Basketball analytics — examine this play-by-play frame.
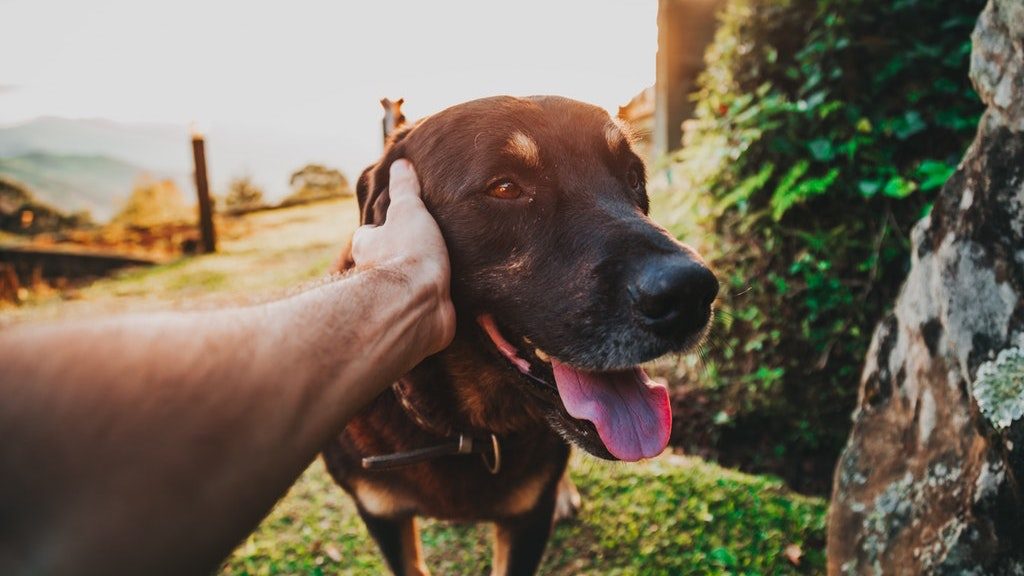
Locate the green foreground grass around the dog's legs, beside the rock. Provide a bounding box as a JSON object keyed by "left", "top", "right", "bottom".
{"left": 221, "top": 455, "right": 825, "bottom": 576}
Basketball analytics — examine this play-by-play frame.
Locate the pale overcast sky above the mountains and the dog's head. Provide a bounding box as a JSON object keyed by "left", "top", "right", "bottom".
{"left": 0, "top": 0, "right": 657, "bottom": 179}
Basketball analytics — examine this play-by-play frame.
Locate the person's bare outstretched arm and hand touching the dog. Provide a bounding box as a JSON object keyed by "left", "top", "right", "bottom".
{"left": 0, "top": 161, "right": 455, "bottom": 574}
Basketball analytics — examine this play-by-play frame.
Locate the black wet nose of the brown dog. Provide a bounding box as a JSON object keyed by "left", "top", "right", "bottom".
{"left": 629, "top": 256, "right": 718, "bottom": 336}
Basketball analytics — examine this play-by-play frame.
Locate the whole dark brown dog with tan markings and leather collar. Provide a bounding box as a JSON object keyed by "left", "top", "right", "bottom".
{"left": 324, "top": 96, "right": 718, "bottom": 574}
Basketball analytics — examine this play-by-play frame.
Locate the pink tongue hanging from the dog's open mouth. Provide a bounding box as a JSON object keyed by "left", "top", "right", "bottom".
{"left": 551, "top": 358, "right": 672, "bottom": 462}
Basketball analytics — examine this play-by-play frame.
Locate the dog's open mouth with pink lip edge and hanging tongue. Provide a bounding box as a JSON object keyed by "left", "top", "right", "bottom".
{"left": 477, "top": 315, "right": 672, "bottom": 461}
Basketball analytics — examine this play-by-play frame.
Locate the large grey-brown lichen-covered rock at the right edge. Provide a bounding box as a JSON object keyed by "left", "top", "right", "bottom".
{"left": 828, "top": 0, "right": 1024, "bottom": 575}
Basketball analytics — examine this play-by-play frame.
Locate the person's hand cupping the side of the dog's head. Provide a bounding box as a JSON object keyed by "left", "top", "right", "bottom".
{"left": 351, "top": 160, "right": 455, "bottom": 356}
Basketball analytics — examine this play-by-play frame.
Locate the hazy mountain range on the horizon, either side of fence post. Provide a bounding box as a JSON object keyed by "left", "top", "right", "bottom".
{"left": 0, "top": 117, "right": 364, "bottom": 219}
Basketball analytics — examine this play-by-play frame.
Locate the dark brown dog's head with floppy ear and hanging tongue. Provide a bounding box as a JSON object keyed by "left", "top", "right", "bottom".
{"left": 357, "top": 96, "right": 718, "bottom": 460}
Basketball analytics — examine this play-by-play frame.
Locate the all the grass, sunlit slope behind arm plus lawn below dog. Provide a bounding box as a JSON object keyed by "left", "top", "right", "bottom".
{"left": 0, "top": 200, "right": 825, "bottom": 575}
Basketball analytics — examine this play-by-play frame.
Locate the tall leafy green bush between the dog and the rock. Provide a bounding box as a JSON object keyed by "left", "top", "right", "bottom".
{"left": 655, "top": 0, "right": 983, "bottom": 490}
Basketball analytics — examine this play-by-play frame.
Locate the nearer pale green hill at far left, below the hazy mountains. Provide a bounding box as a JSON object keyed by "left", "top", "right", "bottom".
{"left": 0, "top": 152, "right": 184, "bottom": 221}
